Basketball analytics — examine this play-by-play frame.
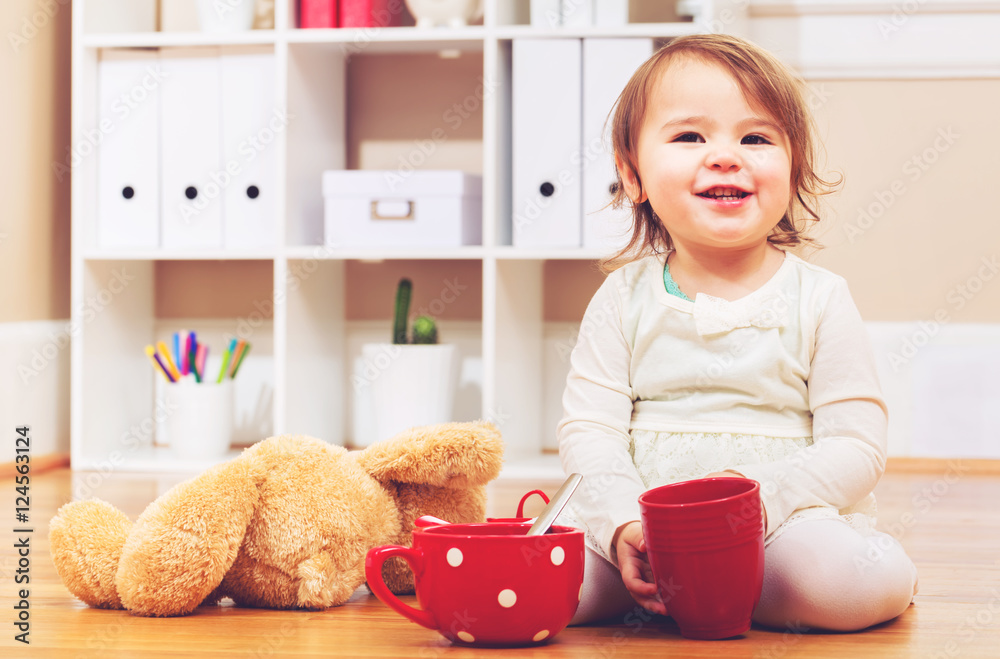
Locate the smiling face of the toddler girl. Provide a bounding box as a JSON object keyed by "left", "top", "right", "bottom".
{"left": 620, "top": 57, "right": 791, "bottom": 250}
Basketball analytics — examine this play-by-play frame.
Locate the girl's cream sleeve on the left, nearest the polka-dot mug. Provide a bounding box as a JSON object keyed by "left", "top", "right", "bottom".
{"left": 558, "top": 275, "right": 646, "bottom": 557}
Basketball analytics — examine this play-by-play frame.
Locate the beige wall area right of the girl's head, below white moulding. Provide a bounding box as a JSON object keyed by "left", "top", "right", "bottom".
{"left": 814, "top": 80, "right": 1000, "bottom": 323}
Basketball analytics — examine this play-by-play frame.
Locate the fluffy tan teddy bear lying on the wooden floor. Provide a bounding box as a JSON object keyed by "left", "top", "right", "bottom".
{"left": 49, "top": 422, "right": 503, "bottom": 616}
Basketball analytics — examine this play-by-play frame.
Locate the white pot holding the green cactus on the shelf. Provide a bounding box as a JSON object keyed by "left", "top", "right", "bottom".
{"left": 354, "top": 343, "right": 459, "bottom": 446}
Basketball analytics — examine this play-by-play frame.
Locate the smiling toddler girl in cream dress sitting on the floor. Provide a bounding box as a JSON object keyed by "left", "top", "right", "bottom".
{"left": 559, "top": 35, "right": 916, "bottom": 630}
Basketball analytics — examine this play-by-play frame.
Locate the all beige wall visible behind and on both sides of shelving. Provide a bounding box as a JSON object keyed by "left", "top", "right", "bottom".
{"left": 0, "top": 10, "right": 1000, "bottom": 322}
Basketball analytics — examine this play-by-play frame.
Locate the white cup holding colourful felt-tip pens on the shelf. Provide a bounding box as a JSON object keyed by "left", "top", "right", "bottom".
{"left": 164, "top": 378, "right": 233, "bottom": 459}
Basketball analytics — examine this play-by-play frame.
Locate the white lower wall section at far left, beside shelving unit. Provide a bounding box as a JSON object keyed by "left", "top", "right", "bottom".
{"left": 0, "top": 320, "right": 70, "bottom": 462}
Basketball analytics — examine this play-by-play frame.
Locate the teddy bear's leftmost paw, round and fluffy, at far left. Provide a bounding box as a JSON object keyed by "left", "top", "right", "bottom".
{"left": 49, "top": 499, "right": 132, "bottom": 609}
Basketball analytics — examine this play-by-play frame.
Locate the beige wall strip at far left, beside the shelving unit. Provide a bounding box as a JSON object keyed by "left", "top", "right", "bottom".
{"left": 0, "top": 0, "right": 70, "bottom": 322}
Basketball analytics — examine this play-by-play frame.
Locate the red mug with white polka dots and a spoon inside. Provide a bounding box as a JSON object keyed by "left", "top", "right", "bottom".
{"left": 365, "top": 522, "right": 584, "bottom": 646}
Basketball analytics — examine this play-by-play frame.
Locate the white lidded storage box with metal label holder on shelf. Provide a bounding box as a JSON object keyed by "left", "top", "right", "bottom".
{"left": 323, "top": 170, "right": 483, "bottom": 247}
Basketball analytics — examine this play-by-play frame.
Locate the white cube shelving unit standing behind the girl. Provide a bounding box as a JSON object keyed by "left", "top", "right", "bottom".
{"left": 71, "top": 0, "right": 746, "bottom": 477}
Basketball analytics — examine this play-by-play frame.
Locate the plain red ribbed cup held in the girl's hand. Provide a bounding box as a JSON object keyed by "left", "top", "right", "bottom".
{"left": 639, "top": 478, "right": 764, "bottom": 639}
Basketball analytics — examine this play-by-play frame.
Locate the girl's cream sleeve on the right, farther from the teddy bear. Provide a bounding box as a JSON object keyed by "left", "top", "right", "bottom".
{"left": 727, "top": 280, "right": 888, "bottom": 535}
